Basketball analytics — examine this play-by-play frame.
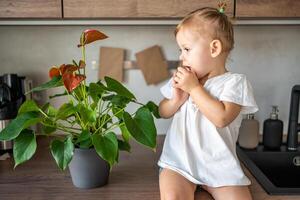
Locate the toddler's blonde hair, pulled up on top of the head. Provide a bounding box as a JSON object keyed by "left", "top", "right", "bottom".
{"left": 175, "top": 7, "right": 234, "bottom": 52}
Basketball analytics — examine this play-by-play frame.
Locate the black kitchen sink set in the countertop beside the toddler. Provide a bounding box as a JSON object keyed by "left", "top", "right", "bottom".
{"left": 236, "top": 144, "right": 300, "bottom": 195}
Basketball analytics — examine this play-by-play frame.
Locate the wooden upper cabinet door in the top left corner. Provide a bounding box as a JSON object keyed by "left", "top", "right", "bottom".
{"left": 0, "top": 0, "right": 62, "bottom": 18}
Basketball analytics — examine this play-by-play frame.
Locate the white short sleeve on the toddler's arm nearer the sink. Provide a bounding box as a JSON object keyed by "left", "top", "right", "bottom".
{"left": 219, "top": 74, "right": 258, "bottom": 114}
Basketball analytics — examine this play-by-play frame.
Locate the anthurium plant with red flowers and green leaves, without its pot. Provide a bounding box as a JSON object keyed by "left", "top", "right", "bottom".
{"left": 0, "top": 29, "right": 159, "bottom": 170}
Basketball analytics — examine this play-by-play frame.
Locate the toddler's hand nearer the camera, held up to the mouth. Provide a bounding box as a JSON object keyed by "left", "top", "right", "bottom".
{"left": 173, "top": 67, "right": 200, "bottom": 94}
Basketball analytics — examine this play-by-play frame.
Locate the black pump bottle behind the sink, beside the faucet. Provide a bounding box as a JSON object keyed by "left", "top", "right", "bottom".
{"left": 263, "top": 106, "right": 283, "bottom": 149}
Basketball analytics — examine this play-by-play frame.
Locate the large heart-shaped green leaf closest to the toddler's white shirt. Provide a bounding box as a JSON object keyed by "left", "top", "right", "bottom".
{"left": 123, "top": 107, "right": 157, "bottom": 148}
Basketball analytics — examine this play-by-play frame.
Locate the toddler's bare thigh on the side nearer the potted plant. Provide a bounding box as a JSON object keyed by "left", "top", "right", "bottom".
{"left": 159, "top": 169, "right": 196, "bottom": 200}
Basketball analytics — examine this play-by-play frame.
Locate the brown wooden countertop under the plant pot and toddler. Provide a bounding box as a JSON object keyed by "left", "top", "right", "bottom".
{"left": 0, "top": 136, "right": 300, "bottom": 200}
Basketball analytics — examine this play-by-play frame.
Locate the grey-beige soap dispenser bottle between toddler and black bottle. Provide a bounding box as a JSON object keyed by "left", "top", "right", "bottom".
{"left": 238, "top": 114, "right": 259, "bottom": 149}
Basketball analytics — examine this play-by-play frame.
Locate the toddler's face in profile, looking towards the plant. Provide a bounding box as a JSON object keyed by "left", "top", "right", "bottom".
{"left": 176, "top": 28, "right": 211, "bottom": 79}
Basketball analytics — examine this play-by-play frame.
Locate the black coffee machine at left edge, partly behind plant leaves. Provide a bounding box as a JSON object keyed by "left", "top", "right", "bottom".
{"left": 0, "top": 74, "right": 26, "bottom": 153}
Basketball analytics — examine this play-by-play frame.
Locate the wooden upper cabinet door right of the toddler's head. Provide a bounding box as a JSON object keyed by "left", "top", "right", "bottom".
{"left": 236, "top": 0, "right": 300, "bottom": 18}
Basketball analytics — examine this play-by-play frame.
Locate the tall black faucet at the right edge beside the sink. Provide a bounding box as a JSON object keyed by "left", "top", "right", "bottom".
{"left": 287, "top": 85, "right": 300, "bottom": 151}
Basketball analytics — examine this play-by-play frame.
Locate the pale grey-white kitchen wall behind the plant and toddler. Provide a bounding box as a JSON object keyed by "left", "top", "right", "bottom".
{"left": 0, "top": 25, "right": 300, "bottom": 133}
